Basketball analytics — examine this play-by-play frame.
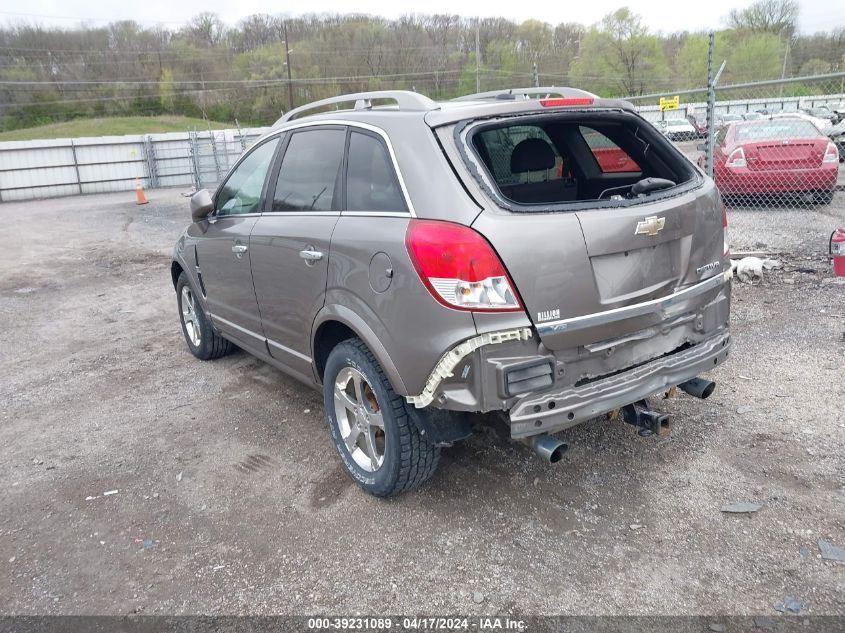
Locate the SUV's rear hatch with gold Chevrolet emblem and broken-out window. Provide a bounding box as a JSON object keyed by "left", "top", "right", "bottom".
{"left": 428, "top": 103, "right": 724, "bottom": 350}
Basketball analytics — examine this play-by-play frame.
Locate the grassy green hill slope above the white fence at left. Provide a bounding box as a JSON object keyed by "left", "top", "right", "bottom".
{"left": 0, "top": 115, "right": 235, "bottom": 141}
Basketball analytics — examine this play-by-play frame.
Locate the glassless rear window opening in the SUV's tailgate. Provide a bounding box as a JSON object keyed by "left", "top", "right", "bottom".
{"left": 467, "top": 113, "right": 695, "bottom": 206}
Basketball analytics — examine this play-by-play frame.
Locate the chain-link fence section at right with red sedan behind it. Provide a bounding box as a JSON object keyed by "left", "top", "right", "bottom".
{"left": 630, "top": 73, "right": 845, "bottom": 208}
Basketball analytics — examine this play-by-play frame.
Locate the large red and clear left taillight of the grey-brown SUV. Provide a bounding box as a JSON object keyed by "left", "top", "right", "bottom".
{"left": 405, "top": 220, "right": 522, "bottom": 312}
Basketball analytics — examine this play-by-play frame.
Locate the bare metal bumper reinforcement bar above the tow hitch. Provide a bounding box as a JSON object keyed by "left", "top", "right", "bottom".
{"left": 510, "top": 330, "right": 731, "bottom": 438}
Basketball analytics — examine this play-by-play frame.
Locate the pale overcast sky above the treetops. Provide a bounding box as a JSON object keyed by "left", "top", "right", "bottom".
{"left": 0, "top": 0, "right": 845, "bottom": 33}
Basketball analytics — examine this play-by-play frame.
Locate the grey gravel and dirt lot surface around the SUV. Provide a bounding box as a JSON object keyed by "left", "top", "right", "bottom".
{"left": 0, "top": 190, "right": 845, "bottom": 617}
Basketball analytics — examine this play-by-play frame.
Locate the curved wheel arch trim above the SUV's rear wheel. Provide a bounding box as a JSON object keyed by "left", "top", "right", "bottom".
{"left": 311, "top": 305, "right": 408, "bottom": 396}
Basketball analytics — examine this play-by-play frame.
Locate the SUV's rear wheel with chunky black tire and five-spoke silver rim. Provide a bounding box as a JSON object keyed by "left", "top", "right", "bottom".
{"left": 323, "top": 338, "right": 440, "bottom": 497}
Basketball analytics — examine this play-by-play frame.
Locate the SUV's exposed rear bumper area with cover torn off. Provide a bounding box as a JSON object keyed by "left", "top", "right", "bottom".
{"left": 407, "top": 271, "right": 730, "bottom": 438}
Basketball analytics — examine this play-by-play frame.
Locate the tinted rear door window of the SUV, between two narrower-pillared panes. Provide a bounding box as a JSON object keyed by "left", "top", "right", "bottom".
{"left": 272, "top": 128, "right": 346, "bottom": 211}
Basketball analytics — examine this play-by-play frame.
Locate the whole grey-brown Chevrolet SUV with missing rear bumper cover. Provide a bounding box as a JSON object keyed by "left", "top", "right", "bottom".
{"left": 171, "top": 88, "right": 730, "bottom": 496}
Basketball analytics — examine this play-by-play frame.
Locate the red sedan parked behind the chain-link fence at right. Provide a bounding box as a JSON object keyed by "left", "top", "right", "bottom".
{"left": 699, "top": 118, "right": 839, "bottom": 204}
